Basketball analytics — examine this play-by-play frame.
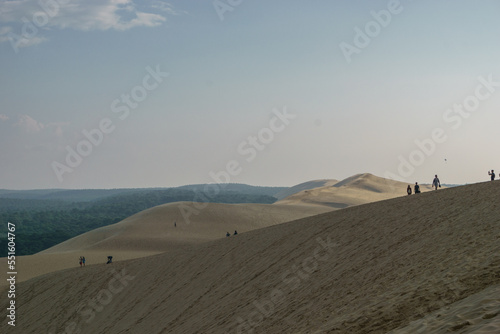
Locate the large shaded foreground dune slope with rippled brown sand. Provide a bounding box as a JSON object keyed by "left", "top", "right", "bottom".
{"left": 4, "top": 182, "right": 500, "bottom": 334}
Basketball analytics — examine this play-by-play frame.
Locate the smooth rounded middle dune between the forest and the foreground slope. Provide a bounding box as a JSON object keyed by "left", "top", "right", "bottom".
{"left": 0, "top": 202, "right": 328, "bottom": 285}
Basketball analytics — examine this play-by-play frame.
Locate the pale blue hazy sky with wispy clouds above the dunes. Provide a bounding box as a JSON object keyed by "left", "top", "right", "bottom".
{"left": 0, "top": 0, "right": 500, "bottom": 189}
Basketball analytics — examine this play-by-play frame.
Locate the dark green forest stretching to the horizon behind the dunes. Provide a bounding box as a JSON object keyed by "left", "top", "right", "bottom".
{"left": 0, "top": 186, "right": 283, "bottom": 257}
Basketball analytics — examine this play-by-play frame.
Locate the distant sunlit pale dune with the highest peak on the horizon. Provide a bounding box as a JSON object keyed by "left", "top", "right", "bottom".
{"left": 277, "top": 173, "right": 432, "bottom": 209}
